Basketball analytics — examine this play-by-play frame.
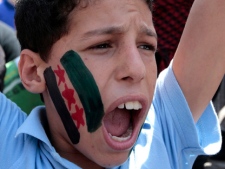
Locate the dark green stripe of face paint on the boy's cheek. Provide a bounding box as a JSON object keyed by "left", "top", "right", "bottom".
{"left": 60, "top": 50, "right": 104, "bottom": 132}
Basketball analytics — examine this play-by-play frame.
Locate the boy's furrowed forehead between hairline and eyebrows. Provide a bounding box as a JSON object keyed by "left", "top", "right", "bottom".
{"left": 70, "top": 0, "right": 154, "bottom": 34}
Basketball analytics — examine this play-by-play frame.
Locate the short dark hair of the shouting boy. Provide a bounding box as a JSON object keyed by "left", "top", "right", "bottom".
{"left": 15, "top": 0, "right": 152, "bottom": 61}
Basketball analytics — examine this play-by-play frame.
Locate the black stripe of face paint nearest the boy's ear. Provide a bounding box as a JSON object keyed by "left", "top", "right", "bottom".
{"left": 44, "top": 67, "right": 80, "bottom": 144}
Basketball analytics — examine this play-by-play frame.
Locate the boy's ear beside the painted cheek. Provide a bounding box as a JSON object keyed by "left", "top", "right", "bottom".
{"left": 18, "top": 49, "right": 47, "bottom": 93}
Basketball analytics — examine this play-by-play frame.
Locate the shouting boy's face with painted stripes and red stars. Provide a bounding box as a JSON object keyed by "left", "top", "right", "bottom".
{"left": 44, "top": 0, "right": 157, "bottom": 167}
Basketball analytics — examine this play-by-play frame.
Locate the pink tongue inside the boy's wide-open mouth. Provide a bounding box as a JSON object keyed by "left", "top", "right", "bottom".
{"left": 104, "top": 109, "right": 131, "bottom": 137}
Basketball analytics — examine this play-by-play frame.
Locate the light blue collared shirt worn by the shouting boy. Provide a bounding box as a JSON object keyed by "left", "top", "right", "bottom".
{"left": 0, "top": 65, "right": 221, "bottom": 169}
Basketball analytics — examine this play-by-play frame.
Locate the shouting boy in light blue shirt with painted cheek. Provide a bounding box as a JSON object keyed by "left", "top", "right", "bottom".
{"left": 0, "top": 0, "right": 225, "bottom": 169}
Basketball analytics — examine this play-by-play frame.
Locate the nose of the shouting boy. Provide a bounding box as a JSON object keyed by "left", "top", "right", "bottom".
{"left": 116, "top": 45, "right": 146, "bottom": 83}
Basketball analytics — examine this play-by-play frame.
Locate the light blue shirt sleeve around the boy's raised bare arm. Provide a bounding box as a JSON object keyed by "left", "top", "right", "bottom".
{"left": 153, "top": 62, "right": 221, "bottom": 168}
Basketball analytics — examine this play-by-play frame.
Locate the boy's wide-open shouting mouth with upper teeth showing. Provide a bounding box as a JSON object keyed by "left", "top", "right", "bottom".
{"left": 103, "top": 101, "right": 143, "bottom": 150}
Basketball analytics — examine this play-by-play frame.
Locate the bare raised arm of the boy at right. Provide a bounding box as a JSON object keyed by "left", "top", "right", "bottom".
{"left": 173, "top": 0, "right": 225, "bottom": 121}
